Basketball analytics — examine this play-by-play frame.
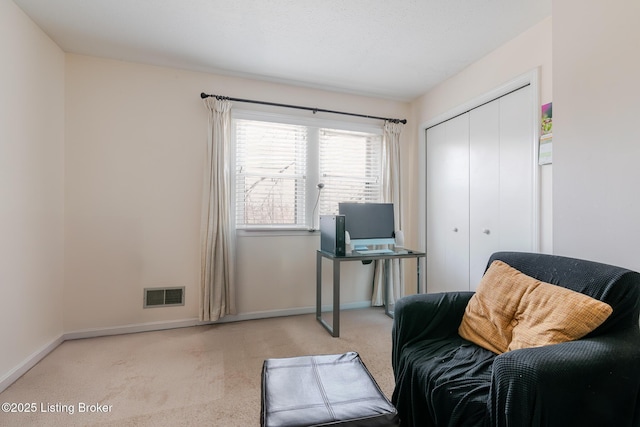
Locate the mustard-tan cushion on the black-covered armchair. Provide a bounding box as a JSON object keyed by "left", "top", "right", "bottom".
{"left": 458, "top": 261, "right": 613, "bottom": 354}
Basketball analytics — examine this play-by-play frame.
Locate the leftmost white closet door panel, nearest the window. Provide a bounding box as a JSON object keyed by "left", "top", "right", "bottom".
{"left": 426, "top": 114, "right": 469, "bottom": 292}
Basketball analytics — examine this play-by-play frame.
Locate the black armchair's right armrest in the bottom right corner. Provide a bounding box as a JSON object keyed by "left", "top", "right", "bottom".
{"left": 488, "top": 328, "right": 640, "bottom": 427}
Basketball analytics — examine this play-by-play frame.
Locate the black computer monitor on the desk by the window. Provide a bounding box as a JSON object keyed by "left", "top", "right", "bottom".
{"left": 338, "top": 202, "right": 395, "bottom": 250}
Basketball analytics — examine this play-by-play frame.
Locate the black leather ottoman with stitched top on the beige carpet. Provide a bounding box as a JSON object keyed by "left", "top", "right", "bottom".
{"left": 260, "top": 352, "right": 400, "bottom": 427}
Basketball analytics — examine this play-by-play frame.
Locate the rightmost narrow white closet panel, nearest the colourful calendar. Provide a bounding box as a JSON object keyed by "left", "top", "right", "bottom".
{"left": 499, "top": 86, "right": 534, "bottom": 251}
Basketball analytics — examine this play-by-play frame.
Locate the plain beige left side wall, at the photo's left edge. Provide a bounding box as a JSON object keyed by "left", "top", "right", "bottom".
{"left": 0, "top": 0, "right": 64, "bottom": 390}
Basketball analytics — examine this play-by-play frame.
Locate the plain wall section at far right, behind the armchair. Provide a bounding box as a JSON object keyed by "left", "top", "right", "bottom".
{"left": 553, "top": 0, "right": 640, "bottom": 270}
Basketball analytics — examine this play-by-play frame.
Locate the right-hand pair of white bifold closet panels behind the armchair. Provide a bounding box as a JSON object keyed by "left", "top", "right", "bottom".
{"left": 469, "top": 86, "right": 534, "bottom": 290}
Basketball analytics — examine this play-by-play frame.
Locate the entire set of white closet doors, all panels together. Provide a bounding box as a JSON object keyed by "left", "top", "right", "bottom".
{"left": 426, "top": 86, "right": 536, "bottom": 292}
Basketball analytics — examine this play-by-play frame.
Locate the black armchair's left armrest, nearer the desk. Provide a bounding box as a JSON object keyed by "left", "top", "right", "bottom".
{"left": 391, "top": 292, "right": 473, "bottom": 372}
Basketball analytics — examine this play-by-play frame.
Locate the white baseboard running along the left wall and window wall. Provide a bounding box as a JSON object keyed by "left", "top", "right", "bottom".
{"left": 0, "top": 301, "right": 371, "bottom": 392}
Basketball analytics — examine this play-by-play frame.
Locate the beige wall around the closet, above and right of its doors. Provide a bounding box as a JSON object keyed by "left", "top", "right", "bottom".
{"left": 411, "top": 17, "right": 553, "bottom": 260}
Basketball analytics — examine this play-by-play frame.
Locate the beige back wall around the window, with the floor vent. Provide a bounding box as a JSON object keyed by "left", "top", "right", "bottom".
{"left": 65, "top": 55, "right": 409, "bottom": 332}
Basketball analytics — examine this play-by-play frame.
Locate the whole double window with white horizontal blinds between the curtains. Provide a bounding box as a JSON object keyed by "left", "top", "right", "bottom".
{"left": 238, "top": 113, "right": 382, "bottom": 229}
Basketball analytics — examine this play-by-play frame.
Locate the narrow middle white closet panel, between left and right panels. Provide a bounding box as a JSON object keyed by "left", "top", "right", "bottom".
{"left": 469, "top": 100, "right": 501, "bottom": 290}
